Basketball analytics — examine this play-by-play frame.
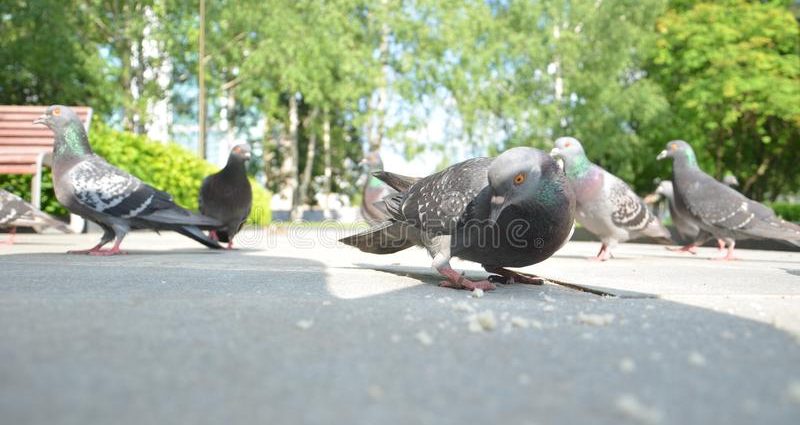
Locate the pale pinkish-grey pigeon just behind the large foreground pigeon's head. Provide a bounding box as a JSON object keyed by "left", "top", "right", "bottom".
{"left": 550, "top": 137, "right": 670, "bottom": 261}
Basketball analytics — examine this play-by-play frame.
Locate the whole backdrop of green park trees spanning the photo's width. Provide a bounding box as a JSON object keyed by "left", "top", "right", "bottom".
{"left": 0, "top": 0, "right": 800, "bottom": 205}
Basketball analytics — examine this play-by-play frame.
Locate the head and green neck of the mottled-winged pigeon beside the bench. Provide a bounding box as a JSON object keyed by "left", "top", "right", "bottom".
{"left": 33, "top": 105, "right": 92, "bottom": 157}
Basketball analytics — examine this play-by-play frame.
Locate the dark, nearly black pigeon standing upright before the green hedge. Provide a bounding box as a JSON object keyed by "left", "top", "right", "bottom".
{"left": 198, "top": 144, "right": 253, "bottom": 249}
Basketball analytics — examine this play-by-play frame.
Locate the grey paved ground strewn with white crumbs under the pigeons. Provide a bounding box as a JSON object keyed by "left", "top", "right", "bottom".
{"left": 0, "top": 226, "right": 800, "bottom": 425}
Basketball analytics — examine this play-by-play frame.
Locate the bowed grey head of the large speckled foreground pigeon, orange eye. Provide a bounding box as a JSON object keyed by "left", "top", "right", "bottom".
{"left": 488, "top": 147, "right": 563, "bottom": 222}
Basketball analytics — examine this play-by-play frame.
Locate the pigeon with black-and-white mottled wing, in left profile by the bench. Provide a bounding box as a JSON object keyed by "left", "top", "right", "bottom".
{"left": 34, "top": 105, "right": 222, "bottom": 255}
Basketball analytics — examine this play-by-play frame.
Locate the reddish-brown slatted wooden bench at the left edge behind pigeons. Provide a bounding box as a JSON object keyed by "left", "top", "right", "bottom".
{"left": 0, "top": 105, "right": 92, "bottom": 232}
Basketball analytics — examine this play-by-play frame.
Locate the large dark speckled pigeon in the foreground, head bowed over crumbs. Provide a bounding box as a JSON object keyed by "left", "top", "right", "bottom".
{"left": 341, "top": 147, "right": 575, "bottom": 290}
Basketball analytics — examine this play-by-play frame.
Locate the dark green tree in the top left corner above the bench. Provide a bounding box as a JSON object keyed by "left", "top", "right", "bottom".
{"left": 0, "top": 0, "right": 119, "bottom": 113}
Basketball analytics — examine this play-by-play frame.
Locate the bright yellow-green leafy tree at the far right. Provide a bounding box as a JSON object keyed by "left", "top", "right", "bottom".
{"left": 648, "top": 0, "right": 800, "bottom": 200}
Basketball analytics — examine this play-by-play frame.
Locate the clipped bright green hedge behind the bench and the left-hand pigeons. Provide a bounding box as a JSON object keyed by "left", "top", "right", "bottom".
{"left": 0, "top": 121, "right": 272, "bottom": 226}
